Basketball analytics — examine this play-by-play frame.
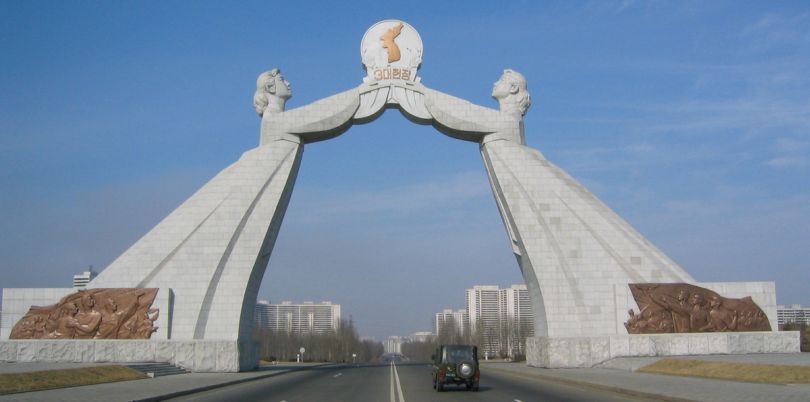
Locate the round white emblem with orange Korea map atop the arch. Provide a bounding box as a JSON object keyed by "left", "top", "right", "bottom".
{"left": 360, "top": 20, "right": 422, "bottom": 82}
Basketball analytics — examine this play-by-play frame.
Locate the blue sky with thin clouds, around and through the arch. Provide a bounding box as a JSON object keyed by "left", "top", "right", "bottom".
{"left": 0, "top": 1, "right": 810, "bottom": 338}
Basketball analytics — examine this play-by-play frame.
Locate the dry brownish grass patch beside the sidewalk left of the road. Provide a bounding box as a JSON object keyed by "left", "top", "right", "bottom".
{"left": 0, "top": 366, "right": 146, "bottom": 395}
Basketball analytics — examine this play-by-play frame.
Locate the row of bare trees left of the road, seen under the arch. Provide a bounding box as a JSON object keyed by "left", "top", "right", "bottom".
{"left": 254, "top": 320, "right": 384, "bottom": 363}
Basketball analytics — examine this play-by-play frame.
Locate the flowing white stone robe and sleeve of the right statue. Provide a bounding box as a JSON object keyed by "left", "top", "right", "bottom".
{"left": 420, "top": 88, "right": 694, "bottom": 337}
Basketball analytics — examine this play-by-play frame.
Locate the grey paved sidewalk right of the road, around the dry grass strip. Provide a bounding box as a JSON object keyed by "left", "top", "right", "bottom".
{"left": 482, "top": 353, "right": 810, "bottom": 402}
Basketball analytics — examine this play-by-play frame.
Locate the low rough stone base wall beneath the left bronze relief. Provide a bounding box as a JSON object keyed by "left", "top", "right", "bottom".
{"left": 0, "top": 340, "right": 259, "bottom": 373}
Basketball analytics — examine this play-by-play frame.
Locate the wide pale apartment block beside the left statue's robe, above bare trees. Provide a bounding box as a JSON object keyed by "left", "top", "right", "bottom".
{"left": 255, "top": 300, "right": 340, "bottom": 334}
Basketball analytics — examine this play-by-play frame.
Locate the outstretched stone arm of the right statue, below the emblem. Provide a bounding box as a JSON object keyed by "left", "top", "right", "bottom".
{"left": 419, "top": 86, "right": 500, "bottom": 142}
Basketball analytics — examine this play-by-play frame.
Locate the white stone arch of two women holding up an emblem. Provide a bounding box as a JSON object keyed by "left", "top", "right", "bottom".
{"left": 89, "top": 20, "right": 784, "bottom": 371}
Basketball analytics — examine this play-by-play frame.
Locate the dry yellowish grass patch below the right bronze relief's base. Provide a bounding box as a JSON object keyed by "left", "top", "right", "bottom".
{"left": 638, "top": 359, "right": 810, "bottom": 384}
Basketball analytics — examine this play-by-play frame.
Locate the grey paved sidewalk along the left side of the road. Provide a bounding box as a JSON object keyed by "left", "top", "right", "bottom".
{"left": 0, "top": 363, "right": 323, "bottom": 402}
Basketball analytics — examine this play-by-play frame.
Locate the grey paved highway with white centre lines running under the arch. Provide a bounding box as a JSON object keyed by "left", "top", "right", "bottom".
{"left": 167, "top": 364, "right": 652, "bottom": 402}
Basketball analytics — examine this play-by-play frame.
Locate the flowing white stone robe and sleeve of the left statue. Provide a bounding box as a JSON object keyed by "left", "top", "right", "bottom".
{"left": 88, "top": 88, "right": 360, "bottom": 341}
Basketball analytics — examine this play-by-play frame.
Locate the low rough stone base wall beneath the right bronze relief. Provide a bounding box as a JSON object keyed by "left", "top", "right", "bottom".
{"left": 526, "top": 331, "right": 800, "bottom": 368}
